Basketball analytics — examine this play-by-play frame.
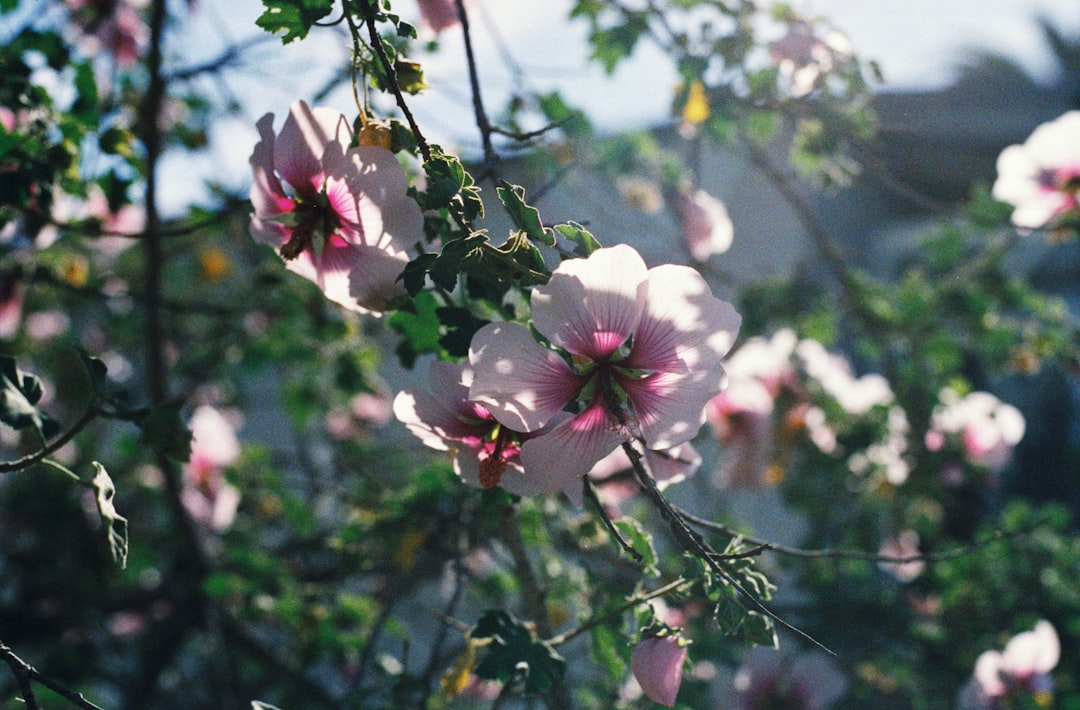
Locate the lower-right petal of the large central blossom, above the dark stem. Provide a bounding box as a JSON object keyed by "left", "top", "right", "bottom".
{"left": 619, "top": 365, "right": 726, "bottom": 448}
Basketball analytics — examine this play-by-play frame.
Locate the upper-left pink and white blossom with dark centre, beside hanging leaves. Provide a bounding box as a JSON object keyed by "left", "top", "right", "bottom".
{"left": 251, "top": 102, "right": 423, "bottom": 312}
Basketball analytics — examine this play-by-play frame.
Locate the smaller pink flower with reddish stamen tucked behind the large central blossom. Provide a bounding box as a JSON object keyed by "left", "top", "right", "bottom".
{"left": 393, "top": 360, "right": 561, "bottom": 496}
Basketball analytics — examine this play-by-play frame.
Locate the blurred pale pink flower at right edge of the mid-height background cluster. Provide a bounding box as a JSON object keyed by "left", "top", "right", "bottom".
{"left": 926, "top": 388, "right": 1025, "bottom": 470}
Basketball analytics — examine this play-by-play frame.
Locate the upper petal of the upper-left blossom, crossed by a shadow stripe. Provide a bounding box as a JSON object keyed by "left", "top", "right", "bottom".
{"left": 274, "top": 102, "right": 352, "bottom": 192}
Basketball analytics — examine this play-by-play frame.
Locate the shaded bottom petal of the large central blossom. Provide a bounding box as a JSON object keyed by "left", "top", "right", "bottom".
{"left": 521, "top": 401, "right": 627, "bottom": 493}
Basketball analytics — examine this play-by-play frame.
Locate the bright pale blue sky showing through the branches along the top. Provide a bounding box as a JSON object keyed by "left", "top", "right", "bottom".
{"left": 157, "top": 0, "right": 1080, "bottom": 213}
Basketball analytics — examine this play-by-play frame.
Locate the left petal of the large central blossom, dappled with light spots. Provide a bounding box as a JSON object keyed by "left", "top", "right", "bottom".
{"left": 469, "top": 323, "right": 586, "bottom": 431}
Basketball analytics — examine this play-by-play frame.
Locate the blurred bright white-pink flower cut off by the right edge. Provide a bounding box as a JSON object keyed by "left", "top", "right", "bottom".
{"left": 993, "top": 111, "right": 1080, "bottom": 229}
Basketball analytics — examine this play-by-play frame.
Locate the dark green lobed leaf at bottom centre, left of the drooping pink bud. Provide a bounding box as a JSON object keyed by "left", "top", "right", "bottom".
{"left": 470, "top": 609, "right": 566, "bottom": 694}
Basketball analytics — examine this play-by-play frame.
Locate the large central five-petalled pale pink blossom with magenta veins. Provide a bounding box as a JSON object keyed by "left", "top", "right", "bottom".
{"left": 469, "top": 245, "right": 741, "bottom": 492}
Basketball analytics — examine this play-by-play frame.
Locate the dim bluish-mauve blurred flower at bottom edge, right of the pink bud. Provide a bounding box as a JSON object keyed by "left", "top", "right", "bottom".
{"left": 734, "top": 646, "right": 848, "bottom": 710}
